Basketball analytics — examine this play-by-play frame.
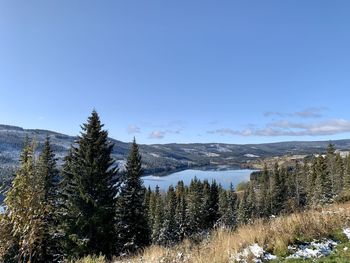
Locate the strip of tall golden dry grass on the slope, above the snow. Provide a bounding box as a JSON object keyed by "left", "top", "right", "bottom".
{"left": 120, "top": 203, "right": 350, "bottom": 263}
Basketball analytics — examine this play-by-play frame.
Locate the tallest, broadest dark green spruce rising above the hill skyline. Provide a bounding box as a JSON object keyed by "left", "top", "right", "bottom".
{"left": 61, "top": 111, "right": 117, "bottom": 257}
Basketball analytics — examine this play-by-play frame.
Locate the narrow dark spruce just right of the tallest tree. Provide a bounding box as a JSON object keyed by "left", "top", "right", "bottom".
{"left": 116, "top": 139, "right": 150, "bottom": 253}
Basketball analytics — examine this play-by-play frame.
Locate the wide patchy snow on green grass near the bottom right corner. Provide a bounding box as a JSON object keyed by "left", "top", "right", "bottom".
{"left": 287, "top": 239, "right": 338, "bottom": 259}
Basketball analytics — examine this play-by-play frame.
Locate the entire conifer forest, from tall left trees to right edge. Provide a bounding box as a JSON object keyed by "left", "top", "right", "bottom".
{"left": 0, "top": 111, "right": 350, "bottom": 263}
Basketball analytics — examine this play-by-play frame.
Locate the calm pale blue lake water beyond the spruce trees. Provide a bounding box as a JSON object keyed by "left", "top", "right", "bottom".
{"left": 142, "top": 169, "right": 255, "bottom": 190}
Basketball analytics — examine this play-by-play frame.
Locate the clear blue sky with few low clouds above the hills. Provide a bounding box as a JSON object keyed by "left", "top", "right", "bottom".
{"left": 0, "top": 0, "right": 350, "bottom": 143}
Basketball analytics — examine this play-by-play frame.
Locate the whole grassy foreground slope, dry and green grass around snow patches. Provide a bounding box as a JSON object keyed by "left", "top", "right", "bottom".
{"left": 116, "top": 203, "right": 350, "bottom": 263}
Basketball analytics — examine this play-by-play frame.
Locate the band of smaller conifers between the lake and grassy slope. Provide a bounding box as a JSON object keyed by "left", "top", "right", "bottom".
{"left": 145, "top": 144, "right": 350, "bottom": 245}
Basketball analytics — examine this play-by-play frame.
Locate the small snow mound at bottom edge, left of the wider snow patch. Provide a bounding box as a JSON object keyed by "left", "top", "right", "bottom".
{"left": 232, "top": 244, "right": 277, "bottom": 263}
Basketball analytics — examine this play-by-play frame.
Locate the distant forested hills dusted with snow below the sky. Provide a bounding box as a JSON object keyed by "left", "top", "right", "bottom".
{"left": 0, "top": 125, "right": 350, "bottom": 175}
